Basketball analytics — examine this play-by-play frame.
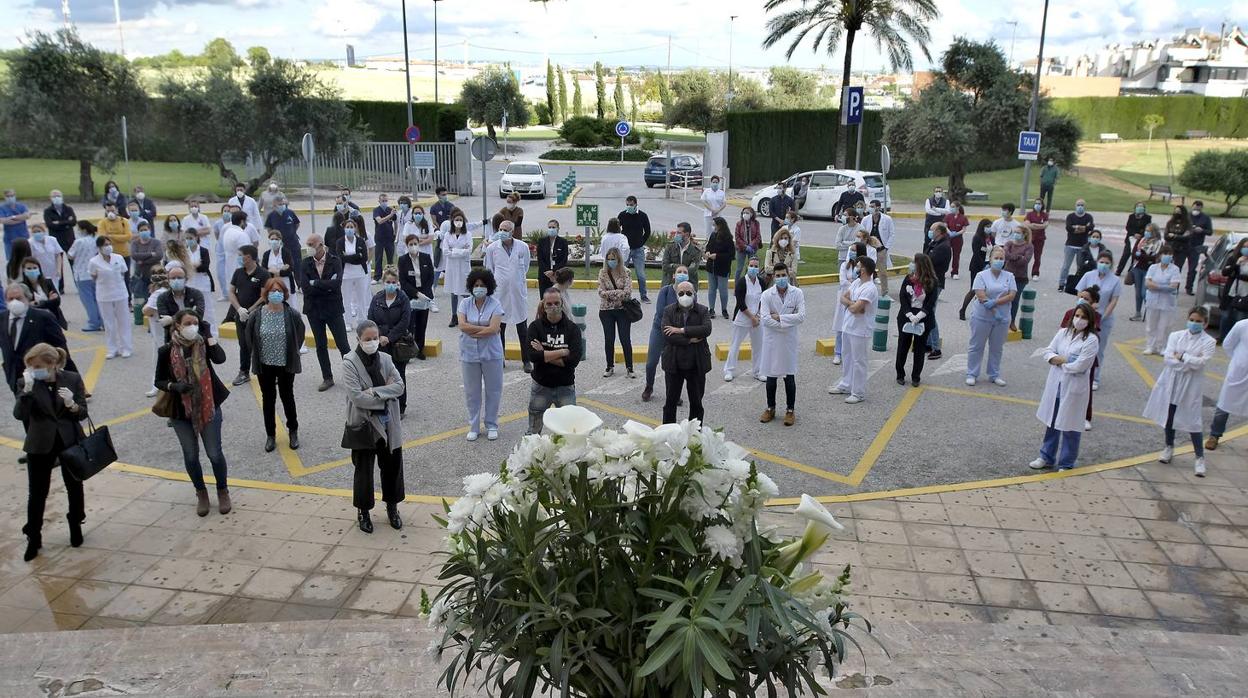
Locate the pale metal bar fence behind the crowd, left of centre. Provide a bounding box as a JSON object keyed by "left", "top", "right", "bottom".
{"left": 273, "top": 142, "right": 458, "bottom": 194}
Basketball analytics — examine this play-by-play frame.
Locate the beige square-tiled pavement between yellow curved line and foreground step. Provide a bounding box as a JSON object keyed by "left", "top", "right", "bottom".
{"left": 0, "top": 434, "right": 1248, "bottom": 633}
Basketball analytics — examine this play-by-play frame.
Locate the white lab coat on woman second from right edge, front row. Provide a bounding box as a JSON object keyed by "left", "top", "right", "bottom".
{"left": 1144, "top": 328, "right": 1218, "bottom": 433}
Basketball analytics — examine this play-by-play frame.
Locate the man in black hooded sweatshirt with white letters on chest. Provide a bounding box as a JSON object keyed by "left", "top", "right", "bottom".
{"left": 527, "top": 286, "right": 584, "bottom": 433}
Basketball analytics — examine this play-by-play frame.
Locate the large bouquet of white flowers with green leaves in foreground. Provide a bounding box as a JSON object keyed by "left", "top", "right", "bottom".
{"left": 429, "top": 406, "right": 870, "bottom": 698}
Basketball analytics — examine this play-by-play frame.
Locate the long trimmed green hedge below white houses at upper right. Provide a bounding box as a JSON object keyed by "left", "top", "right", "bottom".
{"left": 1051, "top": 95, "right": 1248, "bottom": 139}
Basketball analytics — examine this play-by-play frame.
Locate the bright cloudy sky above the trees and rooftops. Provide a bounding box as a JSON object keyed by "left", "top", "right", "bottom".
{"left": 0, "top": 0, "right": 1248, "bottom": 69}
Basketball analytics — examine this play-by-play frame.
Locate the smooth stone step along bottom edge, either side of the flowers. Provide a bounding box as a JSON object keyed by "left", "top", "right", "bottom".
{"left": 0, "top": 618, "right": 1248, "bottom": 697}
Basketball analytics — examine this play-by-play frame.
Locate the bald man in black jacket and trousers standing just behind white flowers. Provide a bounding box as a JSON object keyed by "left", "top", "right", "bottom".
{"left": 663, "top": 281, "right": 710, "bottom": 423}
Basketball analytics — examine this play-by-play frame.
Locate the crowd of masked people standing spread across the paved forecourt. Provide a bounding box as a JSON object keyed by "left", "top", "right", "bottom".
{"left": 0, "top": 177, "right": 1248, "bottom": 559}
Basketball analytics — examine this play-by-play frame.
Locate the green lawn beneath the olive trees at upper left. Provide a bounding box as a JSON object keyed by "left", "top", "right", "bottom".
{"left": 0, "top": 159, "right": 230, "bottom": 202}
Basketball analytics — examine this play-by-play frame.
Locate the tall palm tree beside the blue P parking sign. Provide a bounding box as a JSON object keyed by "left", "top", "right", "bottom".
{"left": 763, "top": 0, "right": 940, "bottom": 165}
